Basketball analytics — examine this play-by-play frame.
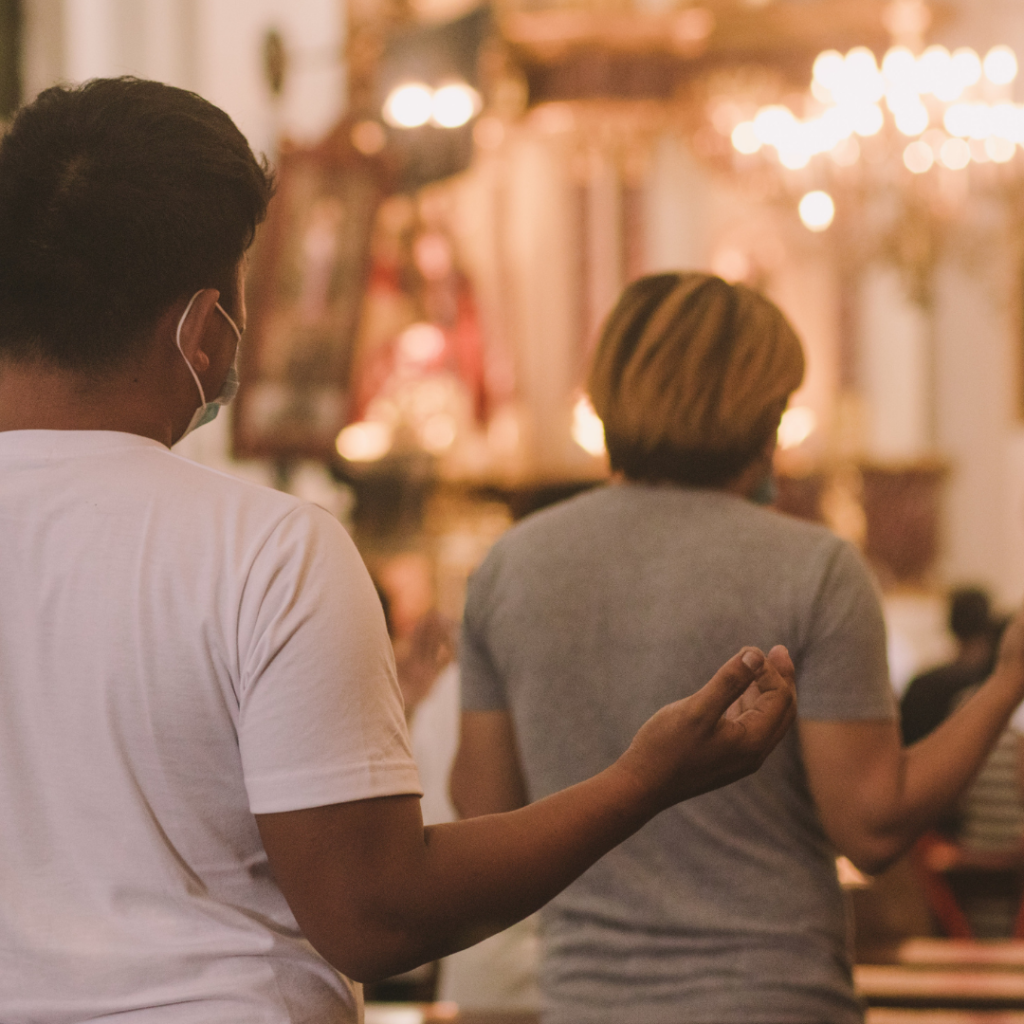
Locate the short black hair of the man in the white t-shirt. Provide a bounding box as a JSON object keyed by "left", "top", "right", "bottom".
{"left": 0, "top": 78, "right": 273, "bottom": 373}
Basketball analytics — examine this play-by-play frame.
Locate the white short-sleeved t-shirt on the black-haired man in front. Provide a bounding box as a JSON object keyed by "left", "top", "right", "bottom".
{"left": 0, "top": 431, "right": 420, "bottom": 1024}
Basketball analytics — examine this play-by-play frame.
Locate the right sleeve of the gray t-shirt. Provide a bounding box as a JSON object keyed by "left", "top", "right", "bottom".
{"left": 796, "top": 542, "right": 897, "bottom": 721}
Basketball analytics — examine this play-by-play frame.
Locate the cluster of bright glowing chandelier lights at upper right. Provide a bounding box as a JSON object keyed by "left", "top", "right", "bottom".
{"left": 719, "top": 37, "right": 1024, "bottom": 231}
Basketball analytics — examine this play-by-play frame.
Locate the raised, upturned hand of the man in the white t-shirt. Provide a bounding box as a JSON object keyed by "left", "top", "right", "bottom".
{"left": 616, "top": 647, "right": 797, "bottom": 810}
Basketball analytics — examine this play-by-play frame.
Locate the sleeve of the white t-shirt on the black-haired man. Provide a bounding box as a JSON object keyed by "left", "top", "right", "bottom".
{"left": 238, "top": 505, "right": 422, "bottom": 814}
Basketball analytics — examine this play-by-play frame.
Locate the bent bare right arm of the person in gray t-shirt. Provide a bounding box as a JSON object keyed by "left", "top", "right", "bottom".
{"left": 799, "top": 613, "right": 1024, "bottom": 872}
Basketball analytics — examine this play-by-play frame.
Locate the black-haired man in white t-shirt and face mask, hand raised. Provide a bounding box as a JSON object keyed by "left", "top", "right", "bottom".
{"left": 0, "top": 79, "right": 794, "bottom": 1024}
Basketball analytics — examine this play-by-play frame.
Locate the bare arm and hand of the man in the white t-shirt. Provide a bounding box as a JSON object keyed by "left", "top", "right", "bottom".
{"left": 256, "top": 648, "right": 795, "bottom": 981}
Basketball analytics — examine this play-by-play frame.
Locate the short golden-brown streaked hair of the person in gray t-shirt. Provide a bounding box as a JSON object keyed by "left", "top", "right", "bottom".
{"left": 589, "top": 273, "right": 804, "bottom": 486}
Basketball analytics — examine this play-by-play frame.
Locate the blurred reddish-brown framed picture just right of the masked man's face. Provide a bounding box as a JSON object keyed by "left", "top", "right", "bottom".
{"left": 234, "top": 126, "right": 386, "bottom": 459}
